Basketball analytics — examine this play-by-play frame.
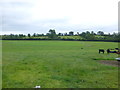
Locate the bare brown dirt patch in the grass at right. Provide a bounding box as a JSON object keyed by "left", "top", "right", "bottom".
{"left": 98, "top": 60, "right": 120, "bottom": 67}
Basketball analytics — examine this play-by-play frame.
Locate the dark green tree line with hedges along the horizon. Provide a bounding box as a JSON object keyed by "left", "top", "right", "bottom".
{"left": 0, "top": 29, "right": 120, "bottom": 42}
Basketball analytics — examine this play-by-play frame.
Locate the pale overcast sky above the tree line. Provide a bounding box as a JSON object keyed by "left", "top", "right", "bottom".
{"left": 0, "top": 0, "right": 119, "bottom": 34}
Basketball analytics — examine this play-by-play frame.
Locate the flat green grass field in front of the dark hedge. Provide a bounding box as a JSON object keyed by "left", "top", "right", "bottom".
{"left": 2, "top": 41, "right": 118, "bottom": 88}
